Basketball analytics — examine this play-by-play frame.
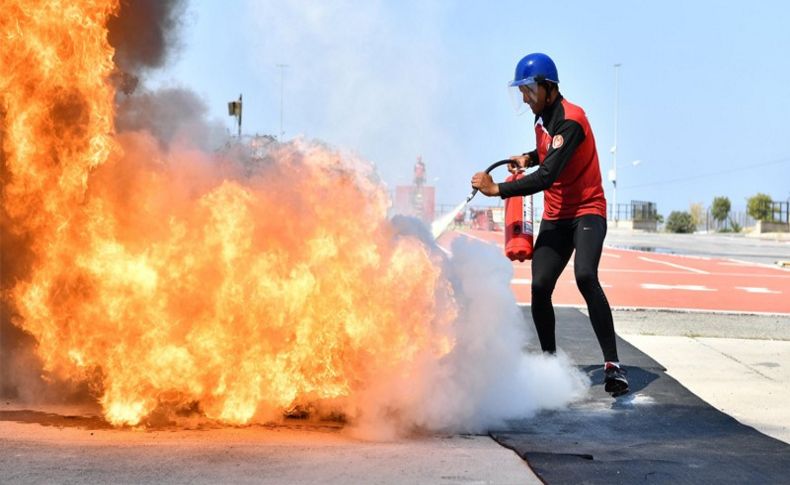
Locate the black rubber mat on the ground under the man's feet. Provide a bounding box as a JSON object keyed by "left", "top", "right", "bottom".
{"left": 491, "top": 307, "right": 790, "bottom": 484}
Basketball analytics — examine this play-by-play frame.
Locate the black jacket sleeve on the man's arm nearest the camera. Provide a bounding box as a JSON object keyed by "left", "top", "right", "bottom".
{"left": 499, "top": 120, "right": 584, "bottom": 199}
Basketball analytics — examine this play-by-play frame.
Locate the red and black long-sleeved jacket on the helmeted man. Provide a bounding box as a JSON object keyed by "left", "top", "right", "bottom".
{"left": 499, "top": 95, "right": 606, "bottom": 220}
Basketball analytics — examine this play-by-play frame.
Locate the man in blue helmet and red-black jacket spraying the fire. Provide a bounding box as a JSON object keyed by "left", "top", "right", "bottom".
{"left": 472, "top": 53, "right": 628, "bottom": 397}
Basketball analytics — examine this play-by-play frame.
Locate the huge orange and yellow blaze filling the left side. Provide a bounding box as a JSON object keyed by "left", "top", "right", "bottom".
{"left": 0, "top": 0, "right": 456, "bottom": 425}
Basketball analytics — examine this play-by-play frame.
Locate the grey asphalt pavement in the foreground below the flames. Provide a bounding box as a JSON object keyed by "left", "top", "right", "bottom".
{"left": 0, "top": 412, "right": 540, "bottom": 485}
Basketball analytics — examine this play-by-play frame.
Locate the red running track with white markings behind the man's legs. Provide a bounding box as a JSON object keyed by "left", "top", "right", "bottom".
{"left": 440, "top": 231, "right": 790, "bottom": 314}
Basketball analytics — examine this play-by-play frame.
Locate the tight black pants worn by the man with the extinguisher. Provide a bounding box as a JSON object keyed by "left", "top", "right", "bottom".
{"left": 532, "top": 215, "right": 618, "bottom": 362}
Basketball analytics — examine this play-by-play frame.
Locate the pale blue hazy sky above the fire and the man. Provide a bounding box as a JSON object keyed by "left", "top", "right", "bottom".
{"left": 151, "top": 0, "right": 790, "bottom": 216}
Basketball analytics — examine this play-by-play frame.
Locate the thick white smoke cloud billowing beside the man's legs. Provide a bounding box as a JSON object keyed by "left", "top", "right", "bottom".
{"left": 440, "top": 237, "right": 589, "bottom": 431}
